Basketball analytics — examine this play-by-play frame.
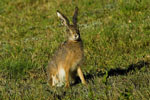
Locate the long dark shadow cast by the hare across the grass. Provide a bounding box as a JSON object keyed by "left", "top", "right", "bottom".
{"left": 72, "top": 61, "right": 150, "bottom": 85}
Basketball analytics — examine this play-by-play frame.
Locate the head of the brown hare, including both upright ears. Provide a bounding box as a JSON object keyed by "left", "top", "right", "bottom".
{"left": 57, "top": 7, "right": 81, "bottom": 41}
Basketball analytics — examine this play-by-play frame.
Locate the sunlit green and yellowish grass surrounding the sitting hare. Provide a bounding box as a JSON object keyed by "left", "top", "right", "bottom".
{"left": 0, "top": 0, "right": 150, "bottom": 100}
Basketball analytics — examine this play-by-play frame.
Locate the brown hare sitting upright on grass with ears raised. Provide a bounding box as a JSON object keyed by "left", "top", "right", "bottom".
{"left": 47, "top": 7, "right": 86, "bottom": 87}
